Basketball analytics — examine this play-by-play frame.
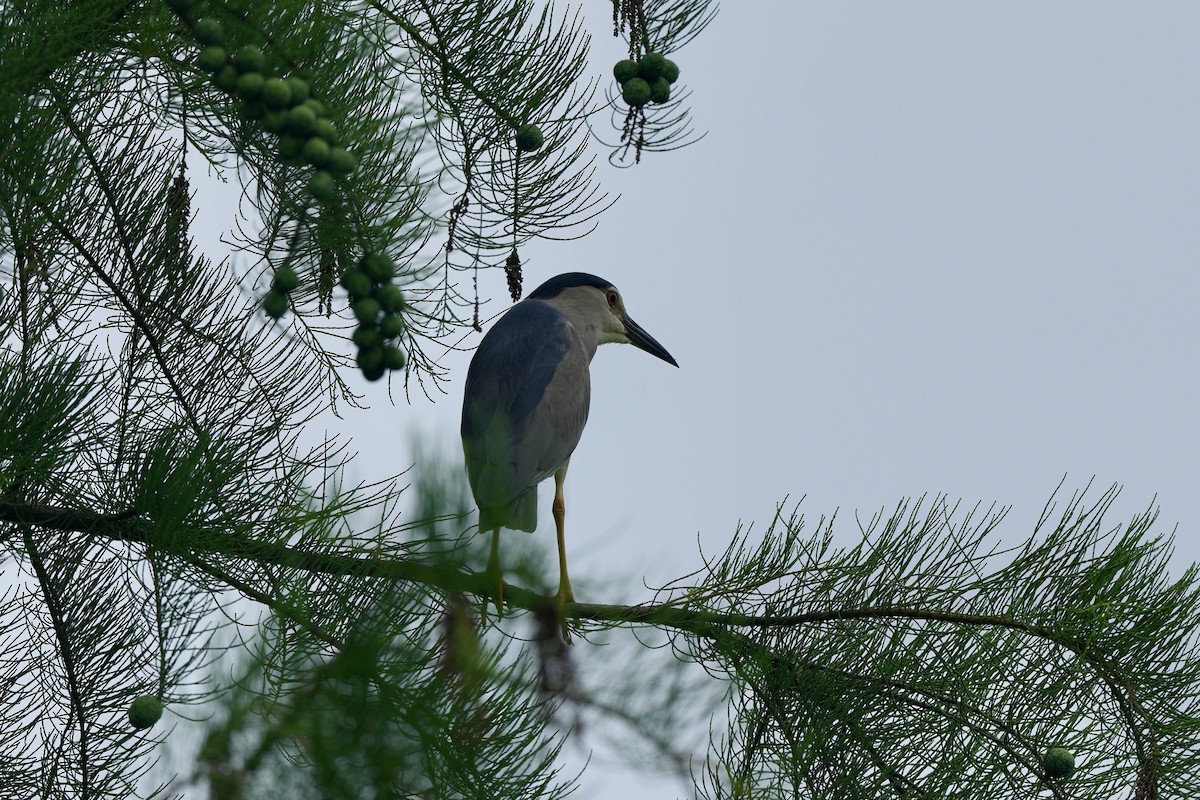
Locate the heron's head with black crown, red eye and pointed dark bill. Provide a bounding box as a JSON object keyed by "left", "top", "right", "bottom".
{"left": 528, "top": 272, "right": 679, "bottom": 367}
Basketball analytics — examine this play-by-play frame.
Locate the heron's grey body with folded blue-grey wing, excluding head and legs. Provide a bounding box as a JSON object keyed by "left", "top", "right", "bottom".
{"left": 462, "top": 300, "right": 590, "bottom": 530}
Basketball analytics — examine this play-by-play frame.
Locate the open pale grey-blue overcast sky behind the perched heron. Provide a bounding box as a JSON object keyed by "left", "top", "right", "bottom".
{"left": 187, "top": 0, "right": 1200, "bottom": 800}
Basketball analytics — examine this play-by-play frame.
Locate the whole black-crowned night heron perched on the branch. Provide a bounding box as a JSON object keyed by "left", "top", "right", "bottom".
{"left": 462, "top": 272, "right": 679, "bottom": 638}
